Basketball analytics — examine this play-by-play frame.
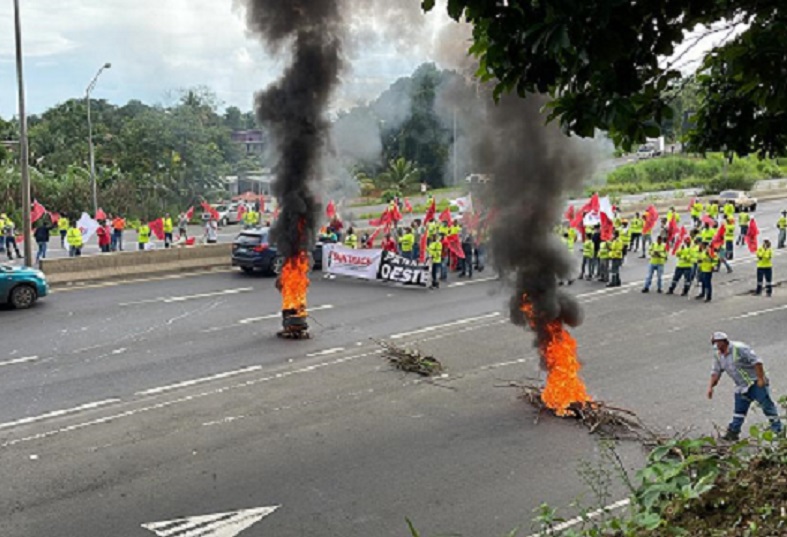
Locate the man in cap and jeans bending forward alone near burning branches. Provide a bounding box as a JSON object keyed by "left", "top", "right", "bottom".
{"left": 708, "top": 332, "right": 783, "bottom": 441}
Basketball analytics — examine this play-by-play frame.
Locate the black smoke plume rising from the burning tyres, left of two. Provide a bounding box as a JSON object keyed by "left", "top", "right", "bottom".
{"left": 246, "top": 0, "right": 342, "bottom": 258}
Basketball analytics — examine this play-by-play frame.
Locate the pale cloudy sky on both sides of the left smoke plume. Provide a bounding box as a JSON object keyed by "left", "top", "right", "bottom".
{"left": 0, "top": 0, "right": 453, "bottom": 118}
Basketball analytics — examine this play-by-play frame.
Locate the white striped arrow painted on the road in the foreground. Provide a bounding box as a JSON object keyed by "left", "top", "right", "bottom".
{"left": 142, "top": 505, "right": 279, "bottom": 537}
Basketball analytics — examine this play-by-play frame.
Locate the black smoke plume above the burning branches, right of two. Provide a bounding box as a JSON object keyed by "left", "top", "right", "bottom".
{"left": 439, "top": 77, "right": 594, "bottom": 350}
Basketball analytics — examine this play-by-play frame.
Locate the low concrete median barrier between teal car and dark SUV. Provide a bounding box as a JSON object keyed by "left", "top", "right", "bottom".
{"left": 41, "top": 243, "right": 232, "bottom": 284}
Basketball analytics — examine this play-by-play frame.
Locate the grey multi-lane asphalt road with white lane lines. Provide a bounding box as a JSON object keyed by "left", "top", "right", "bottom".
{"left": 0, "top": 199, "right": 787, "bottom": 537}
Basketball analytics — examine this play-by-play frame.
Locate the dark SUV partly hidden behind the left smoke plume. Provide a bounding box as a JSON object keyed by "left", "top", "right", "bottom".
{"left": 232, "top": 227, "right": 323, "bottom": 276}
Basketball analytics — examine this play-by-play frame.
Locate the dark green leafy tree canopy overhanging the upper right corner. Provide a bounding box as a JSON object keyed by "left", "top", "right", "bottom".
{"left": 422, "top": 0, "right": 787, "bottom": 155}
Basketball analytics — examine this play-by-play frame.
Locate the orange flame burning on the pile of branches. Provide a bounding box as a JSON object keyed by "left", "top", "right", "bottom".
{"left": 521, "top": 297, "right": 593, "bottom": 416}
